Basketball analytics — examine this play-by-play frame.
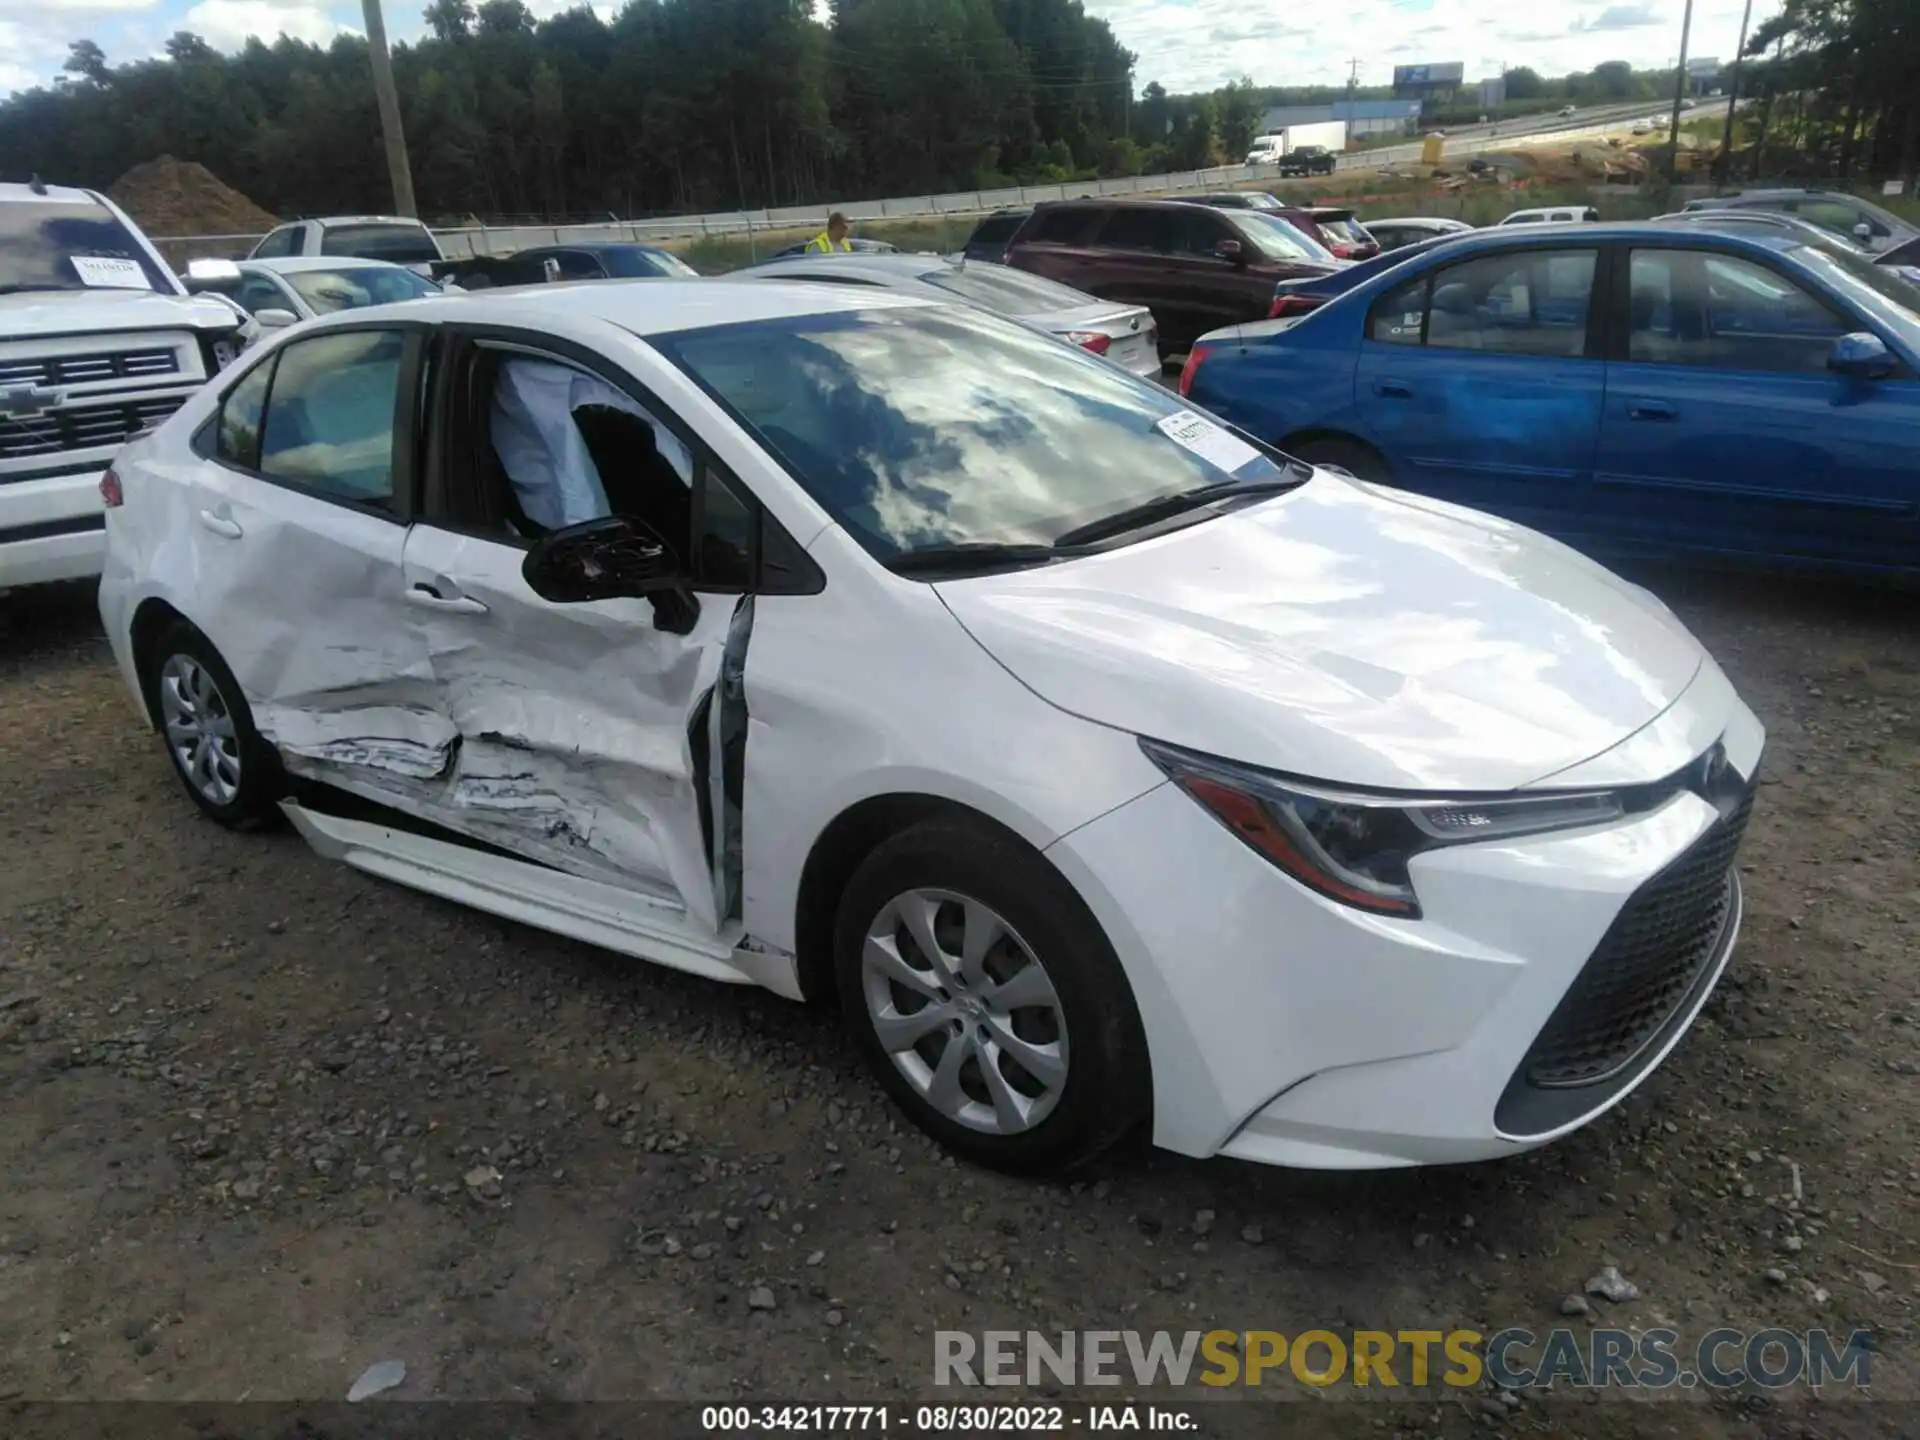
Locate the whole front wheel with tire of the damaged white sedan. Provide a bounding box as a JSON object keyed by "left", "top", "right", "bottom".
{"left": 835, "top": 820, "right": 1150, "bottom": 1173}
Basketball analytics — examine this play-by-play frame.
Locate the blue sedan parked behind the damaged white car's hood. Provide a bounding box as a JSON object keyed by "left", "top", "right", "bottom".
{"left": 1181, "top": 225, "right": 1920, "bottom": 574}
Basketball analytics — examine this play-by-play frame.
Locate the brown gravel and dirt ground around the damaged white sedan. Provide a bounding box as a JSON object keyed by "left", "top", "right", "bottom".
{"left": 0, "top": 572, "right": 1920, "bottom": 1436}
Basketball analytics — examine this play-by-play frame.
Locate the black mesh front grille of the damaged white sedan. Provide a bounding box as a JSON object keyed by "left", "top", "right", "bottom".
{"left": 1521, "top": 791, "right": 1753, "bottom": 1089}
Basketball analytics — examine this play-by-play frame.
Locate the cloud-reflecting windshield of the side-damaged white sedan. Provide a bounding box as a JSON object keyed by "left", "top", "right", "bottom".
{"left": 651, "top": 305, "right": 1288, "bottom": 561}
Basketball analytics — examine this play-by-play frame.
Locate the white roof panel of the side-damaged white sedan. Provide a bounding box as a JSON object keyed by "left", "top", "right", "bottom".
{"left": 321, "top": 276, "right": 935, "bottom": 336}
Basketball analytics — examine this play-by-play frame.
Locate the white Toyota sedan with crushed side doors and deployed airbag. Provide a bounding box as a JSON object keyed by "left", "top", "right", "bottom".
{"left": 100, "top": 280, "right": 1763, "bottom": 1169}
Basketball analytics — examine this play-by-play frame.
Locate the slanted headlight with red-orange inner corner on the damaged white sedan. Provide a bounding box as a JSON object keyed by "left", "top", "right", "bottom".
{"left": 1140, "top": 739, "right": 1628, "bottom": 920}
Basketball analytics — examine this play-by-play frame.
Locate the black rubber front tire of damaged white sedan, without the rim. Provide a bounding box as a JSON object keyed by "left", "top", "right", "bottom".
{"left": 833, "top": 820, "right": 1152, "bottom": 1175}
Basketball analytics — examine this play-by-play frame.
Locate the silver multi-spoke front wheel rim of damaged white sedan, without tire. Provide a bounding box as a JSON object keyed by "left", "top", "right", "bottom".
{"left": 860, "top": 889, "right": 1068, "bottom": 1135}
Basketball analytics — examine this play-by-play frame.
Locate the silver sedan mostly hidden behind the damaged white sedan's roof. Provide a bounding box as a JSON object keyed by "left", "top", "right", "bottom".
{"left": 739, "top": 253, "right": 1160, "bottom": 378}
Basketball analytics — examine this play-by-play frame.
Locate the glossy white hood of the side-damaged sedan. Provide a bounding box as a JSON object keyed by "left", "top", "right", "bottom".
{"left": 937, "top": 472, "right": 1705, "bottom": 791}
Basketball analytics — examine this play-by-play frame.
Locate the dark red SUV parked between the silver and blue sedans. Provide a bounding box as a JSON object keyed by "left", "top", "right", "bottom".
{"left": 1006, "top": 200, "right": 1336, "bottom": 353}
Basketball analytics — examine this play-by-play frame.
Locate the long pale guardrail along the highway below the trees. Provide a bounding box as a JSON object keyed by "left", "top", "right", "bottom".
{"left": 156, "top": 100, "right": 1726, "bottom": 259}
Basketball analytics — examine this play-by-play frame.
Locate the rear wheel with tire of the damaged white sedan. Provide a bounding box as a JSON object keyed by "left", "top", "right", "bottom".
{"left": 146, "top": 620, "right": 286, "bottom": 829}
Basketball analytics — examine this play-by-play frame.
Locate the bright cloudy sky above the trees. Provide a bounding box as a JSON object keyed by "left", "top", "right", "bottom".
{"left": 0, "top": 0, "right": 1780, "bottom": 94}
